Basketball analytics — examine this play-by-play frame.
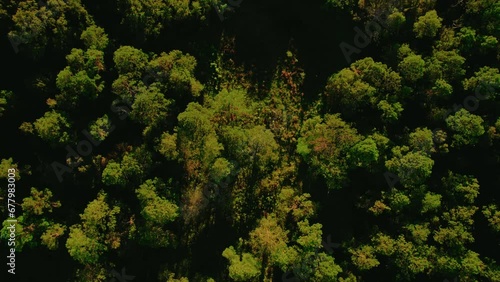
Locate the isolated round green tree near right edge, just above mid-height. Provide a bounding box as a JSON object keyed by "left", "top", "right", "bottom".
{"left": 446, "top": 109, "right": 486, "bottom": 147}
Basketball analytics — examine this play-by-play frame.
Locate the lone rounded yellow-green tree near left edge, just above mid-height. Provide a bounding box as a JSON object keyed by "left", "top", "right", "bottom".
{"left": 33, "top": 110, "right": 70, "bottom": 144}
